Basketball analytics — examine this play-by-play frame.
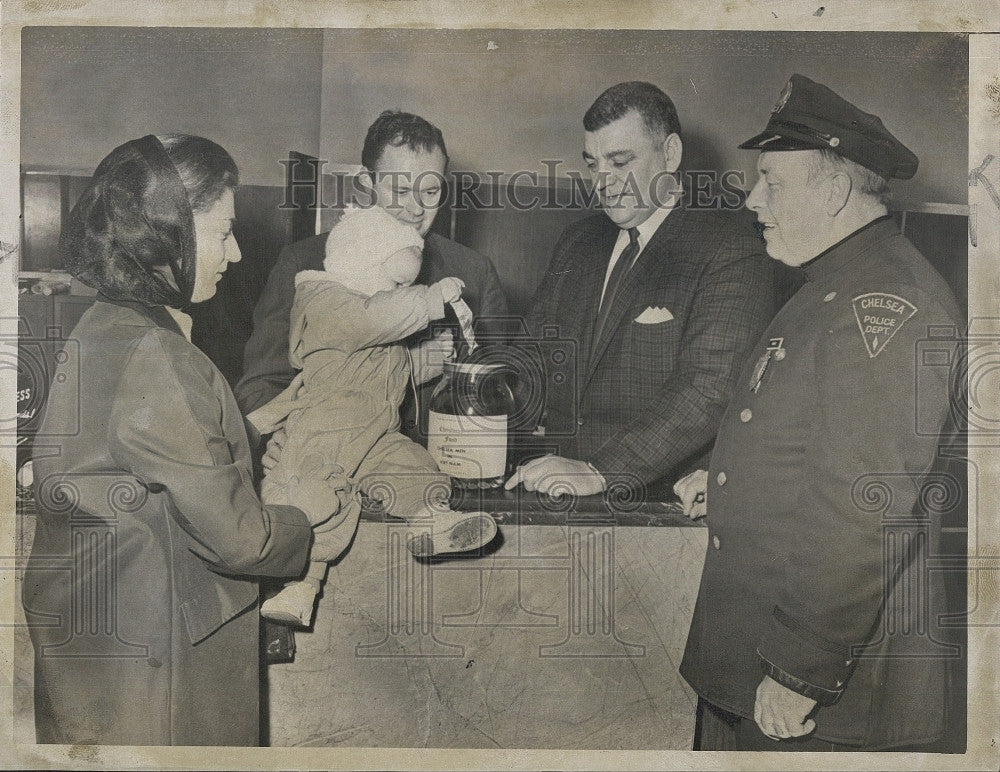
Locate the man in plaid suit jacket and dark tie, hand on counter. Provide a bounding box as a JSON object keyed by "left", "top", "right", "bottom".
{"left": 507, "top": 82, "right": 775, "bottom": 495}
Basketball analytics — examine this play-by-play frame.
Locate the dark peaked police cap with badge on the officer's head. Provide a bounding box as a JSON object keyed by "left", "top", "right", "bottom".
{"left": 740, "top": 75, "right": 917, "bottom": 180}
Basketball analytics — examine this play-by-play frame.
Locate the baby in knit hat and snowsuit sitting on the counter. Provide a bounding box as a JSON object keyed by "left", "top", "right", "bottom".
{"left": 254, "top": 206, "right": 497, "bottom": 627}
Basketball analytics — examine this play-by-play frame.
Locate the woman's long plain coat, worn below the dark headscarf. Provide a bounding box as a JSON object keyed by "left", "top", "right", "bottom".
{"left": 24, "top": 299, "right": 312, "bottom": 745}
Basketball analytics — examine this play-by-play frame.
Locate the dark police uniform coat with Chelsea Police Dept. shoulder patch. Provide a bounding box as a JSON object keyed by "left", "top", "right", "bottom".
{"left": 681, "top": 217, "right": 959, "bottom": 748}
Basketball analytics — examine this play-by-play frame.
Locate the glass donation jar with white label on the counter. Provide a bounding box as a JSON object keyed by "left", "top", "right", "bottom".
{"left": 427, "top": 362, "right": 514, "bottom": 488}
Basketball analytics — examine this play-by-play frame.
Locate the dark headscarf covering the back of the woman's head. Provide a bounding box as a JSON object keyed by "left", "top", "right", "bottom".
{"left": 59, "top": 134, "right": 195, "bottom": 308}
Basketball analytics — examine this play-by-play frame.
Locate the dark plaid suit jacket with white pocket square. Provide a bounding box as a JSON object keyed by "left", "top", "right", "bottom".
{"left": 526, "top": 207, "right": 776, "bottom": 484}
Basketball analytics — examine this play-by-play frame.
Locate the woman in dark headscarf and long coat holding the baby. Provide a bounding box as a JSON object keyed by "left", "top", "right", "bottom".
{"left": 24, "top": 135, "right": 335, "bottom": 745}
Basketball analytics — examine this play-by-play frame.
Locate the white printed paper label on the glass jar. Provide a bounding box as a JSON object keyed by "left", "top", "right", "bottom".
{"left": 427, "top": 410, "right": 507, "bottom": 480}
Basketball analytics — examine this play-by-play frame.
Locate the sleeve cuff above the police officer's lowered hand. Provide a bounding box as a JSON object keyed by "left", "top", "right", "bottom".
{"left": 757, "top": 606, "right": 854, "bottom": 705}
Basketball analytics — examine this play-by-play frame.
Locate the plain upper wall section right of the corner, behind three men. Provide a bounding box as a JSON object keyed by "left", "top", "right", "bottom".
{"left": 320, "top": 29, "right": 969, "bottom": 204}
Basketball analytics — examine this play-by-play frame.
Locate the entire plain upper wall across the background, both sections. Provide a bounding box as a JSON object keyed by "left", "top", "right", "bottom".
{"left": 21, "top": 27, "right": 969, "bottom": 203}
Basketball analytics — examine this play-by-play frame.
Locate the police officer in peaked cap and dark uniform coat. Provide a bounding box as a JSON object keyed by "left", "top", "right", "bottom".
{"left": 676, "top": 75, "right": 961, "bottom": 750}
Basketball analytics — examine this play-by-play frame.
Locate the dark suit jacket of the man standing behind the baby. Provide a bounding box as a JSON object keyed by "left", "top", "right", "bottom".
{"left": 234, "top": 233, "right": 507, "bottom": 437}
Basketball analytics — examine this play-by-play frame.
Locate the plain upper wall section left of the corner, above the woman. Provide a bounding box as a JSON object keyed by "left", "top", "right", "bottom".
{"left": 21, "top": 27, "right": 322, "bottom": 185}
